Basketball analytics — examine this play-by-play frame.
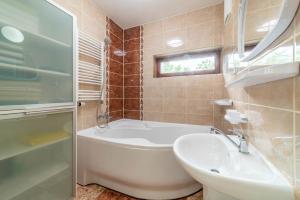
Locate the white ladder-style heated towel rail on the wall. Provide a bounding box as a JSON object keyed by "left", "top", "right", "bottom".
{"left": 78, "top": 32, "right": 105, "bottom": 101}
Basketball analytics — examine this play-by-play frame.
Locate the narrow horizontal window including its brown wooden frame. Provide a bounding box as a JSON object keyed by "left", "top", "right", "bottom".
{"left": 155, "top": 49, "right": 221, "bottom": 77}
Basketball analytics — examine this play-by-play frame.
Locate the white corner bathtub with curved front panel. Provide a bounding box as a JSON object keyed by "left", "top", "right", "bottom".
{"left": 77, "top": 119, "right": 211, "bottom": 199}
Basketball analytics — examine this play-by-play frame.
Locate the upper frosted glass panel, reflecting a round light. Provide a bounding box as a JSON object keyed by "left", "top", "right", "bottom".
{"left": 0, "top": 0, "right": 73, "bottom": 106}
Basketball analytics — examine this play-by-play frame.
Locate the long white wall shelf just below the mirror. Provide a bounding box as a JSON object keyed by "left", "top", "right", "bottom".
{"left": 225, "top": 63, "right": 299, "bottom": 88}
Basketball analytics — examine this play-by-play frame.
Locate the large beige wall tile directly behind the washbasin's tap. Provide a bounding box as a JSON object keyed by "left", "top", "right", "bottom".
{"left": 248, "top": 106, "right": 293, "bottom": 182}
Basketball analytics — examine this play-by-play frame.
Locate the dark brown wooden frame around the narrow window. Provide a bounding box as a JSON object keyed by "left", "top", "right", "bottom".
{"left": 154, "top": 49, "right": 221, "bottom": 78}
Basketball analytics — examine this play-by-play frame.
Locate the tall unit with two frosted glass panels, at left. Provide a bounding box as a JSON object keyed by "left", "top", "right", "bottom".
{"left": 0, "top": 0, "right": 76, "bottom": 200}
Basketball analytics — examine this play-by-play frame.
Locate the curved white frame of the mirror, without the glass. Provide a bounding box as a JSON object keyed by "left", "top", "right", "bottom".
{"left": 238, "top": 0, "right": 300, "bottom": 62}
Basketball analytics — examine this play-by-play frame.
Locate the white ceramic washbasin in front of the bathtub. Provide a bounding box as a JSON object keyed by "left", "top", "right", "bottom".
{"left": 173, "top": 134, "right": 294, "bottom": 200}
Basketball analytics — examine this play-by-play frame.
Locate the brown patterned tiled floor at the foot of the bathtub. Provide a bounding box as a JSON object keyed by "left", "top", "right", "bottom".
{"left": 76, "top": 185, "right": 203, "bottom": 200}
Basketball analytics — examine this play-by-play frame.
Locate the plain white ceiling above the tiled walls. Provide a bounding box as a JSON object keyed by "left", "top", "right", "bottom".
{"left": 94, "top": 0, "right": 223, "bottom": 28}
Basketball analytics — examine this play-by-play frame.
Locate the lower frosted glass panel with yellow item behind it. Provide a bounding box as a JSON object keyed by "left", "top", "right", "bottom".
{"left": 0, "top": 112, "right": 73, "bottom": 200}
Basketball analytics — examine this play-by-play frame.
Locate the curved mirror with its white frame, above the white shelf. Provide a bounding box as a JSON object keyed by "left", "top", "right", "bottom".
{"left": 238, "top": 0, "right": 300, "bottom": 61}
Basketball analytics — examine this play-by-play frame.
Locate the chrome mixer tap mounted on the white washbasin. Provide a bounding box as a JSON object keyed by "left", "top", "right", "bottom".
{"left": 211, "top": 128, "right": 249, "bottom": 154}
